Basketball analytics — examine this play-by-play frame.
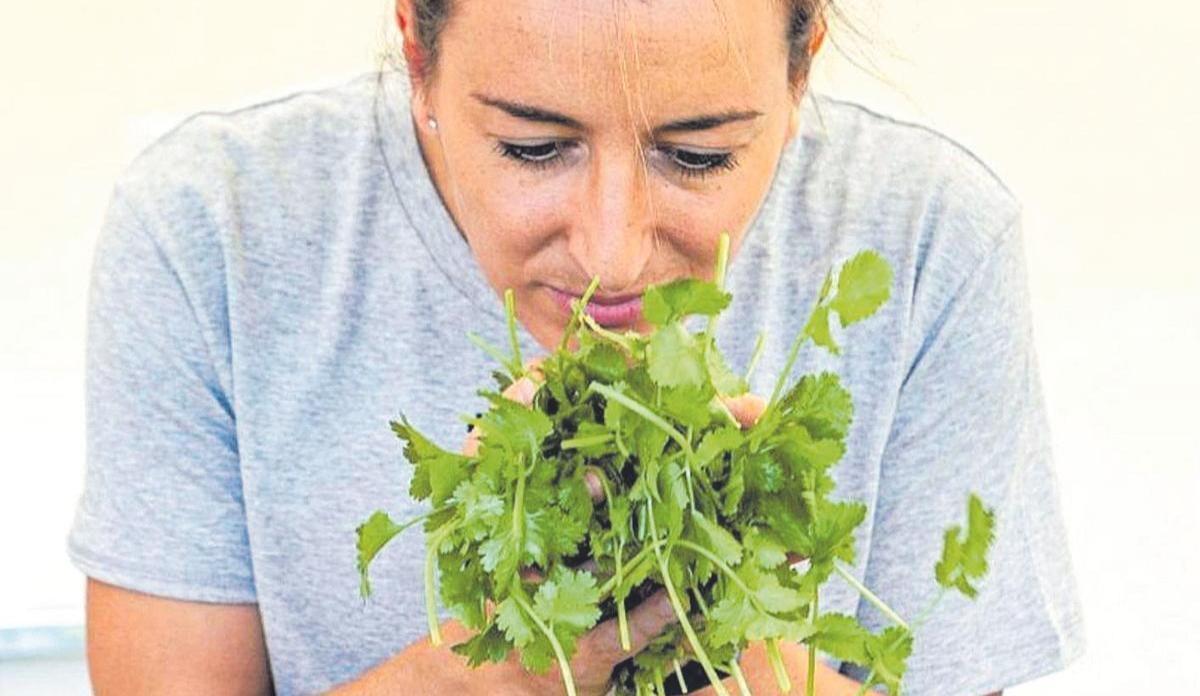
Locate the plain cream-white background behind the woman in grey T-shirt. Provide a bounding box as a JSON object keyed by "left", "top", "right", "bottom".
{"left": 0, "top": 0, "right": 1200, "bottom": 696}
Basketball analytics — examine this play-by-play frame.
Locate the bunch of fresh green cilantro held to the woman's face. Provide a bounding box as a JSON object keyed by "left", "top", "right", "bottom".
{"left": 358, "top": 236, "right": 994, "bottom": 696}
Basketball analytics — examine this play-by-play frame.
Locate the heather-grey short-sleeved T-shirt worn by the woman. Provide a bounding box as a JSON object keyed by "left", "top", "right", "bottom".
{"left": 68, "top": 72, "right": 1082, "bottom": 696}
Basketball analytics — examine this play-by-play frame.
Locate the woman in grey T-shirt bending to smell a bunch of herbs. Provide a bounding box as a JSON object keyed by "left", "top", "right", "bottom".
{"left": 70, "top": 0, "right": 1081, "bottom": 695}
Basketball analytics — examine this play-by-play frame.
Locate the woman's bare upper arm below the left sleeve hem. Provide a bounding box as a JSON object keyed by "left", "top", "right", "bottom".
{"left": 88, "top": 580, "right": 272, "bottom": 696}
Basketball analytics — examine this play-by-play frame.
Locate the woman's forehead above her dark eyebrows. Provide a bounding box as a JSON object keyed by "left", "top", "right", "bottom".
{"left": 438, "top": 0, "right": 787, "bottom": 116}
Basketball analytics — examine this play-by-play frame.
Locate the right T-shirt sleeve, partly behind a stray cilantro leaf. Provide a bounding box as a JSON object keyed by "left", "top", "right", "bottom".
{"left": 846, "top": 218, "right": 1084, "bottom": 696}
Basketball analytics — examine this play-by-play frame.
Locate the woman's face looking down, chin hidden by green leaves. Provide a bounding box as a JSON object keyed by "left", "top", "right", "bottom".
{"left": 402, "top": 0, "right": 816, "bottom": 348}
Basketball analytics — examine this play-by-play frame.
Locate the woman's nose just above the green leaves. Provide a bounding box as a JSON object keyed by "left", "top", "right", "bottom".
{"left": 568, "top": 144, "right": 655, "bottom": 294}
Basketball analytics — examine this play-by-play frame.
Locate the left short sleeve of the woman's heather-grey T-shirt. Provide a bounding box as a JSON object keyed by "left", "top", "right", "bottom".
{"left": 67, "top": 181, "right": 256, "bottom": 602}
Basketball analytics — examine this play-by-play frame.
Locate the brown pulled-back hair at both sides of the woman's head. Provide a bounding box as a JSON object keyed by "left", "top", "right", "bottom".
{"left": 393, "top": 0, "right": 833, "bottom": 88}
